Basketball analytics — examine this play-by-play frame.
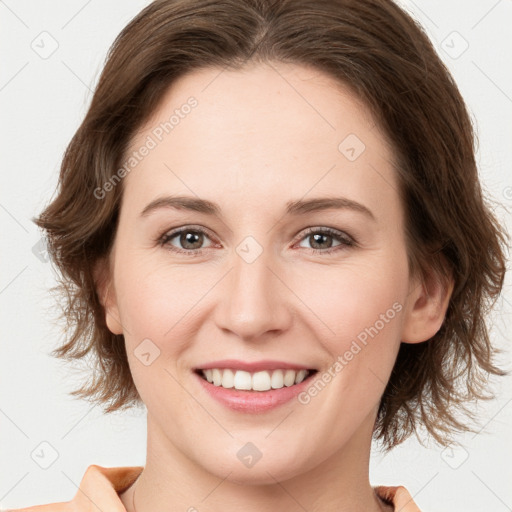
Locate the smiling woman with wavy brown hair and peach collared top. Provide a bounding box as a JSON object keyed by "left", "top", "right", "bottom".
{"left": 9, "top": 0, "right": 505, "bottom": 512}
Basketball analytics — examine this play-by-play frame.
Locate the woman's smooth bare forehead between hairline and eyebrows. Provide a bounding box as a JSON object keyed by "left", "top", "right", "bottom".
{"left": 122, "top": 63, "right": 396, "bottom": 219}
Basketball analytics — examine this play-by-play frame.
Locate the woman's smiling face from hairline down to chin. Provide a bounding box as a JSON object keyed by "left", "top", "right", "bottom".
{"left": 102, "top": 64, "right": 438, "bottom": 483}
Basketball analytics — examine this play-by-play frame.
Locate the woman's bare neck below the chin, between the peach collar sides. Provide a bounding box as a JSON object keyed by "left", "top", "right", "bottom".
{"left": 120, "top": 414, "right": 393, "bottom": 512}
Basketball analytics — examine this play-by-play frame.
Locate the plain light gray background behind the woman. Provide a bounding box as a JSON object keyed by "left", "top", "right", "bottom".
{"left": 0, "top": 0, "right": 512, "bottom": 512}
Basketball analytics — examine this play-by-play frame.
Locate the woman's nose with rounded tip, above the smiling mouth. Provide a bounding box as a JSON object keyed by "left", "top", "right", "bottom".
{"left": 214, "top": 245, "right": 293, "bottom": 341}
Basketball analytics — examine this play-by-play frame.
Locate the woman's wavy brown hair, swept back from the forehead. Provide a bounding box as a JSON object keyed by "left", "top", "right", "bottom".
{"left": 35, "top": 0, "right": 508, "bottom": 449}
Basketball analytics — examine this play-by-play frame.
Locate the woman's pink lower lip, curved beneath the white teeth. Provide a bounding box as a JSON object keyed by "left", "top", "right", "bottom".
{"left": 194, "top": 372, "right": 316, "bottom": 413}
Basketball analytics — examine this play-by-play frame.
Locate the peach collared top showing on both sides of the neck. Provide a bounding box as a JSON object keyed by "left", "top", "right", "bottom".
{"left": 9, "top": 464, "right": 421, "bottom": 512}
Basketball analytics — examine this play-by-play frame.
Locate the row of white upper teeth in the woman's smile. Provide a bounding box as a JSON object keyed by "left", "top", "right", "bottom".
{"left": 201, "top": 368, "right": 308, "bottom": 391}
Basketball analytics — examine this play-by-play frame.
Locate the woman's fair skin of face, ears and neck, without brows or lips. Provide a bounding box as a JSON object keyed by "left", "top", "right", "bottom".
{"left": 98, "top": 63, "right": 451, "bottom": 512}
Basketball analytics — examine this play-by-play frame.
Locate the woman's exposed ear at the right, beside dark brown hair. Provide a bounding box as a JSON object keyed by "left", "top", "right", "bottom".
{"left": 402, "top": 264, "right": 454, "bottom": 343}
